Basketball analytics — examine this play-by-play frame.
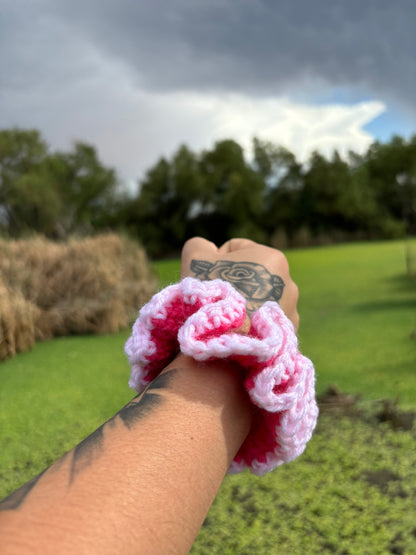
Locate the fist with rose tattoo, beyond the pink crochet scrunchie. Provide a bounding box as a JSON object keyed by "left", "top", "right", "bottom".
{"left": 181, "top": 237, "right": 299, "bottom": 330}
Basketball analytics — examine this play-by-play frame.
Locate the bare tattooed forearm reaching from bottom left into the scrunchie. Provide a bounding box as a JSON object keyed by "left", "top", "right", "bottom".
{"left": 0, "top": 355, "right": 250, "bottom": 554}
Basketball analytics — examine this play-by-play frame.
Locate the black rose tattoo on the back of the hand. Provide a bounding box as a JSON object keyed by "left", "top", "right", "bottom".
{"left": 191, "top": 260, "right": 285, "bottom": 313}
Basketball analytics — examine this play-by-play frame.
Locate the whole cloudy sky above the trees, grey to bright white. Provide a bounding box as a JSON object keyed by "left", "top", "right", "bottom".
{"left": 0, "top": 0, "right": 416, "bottom": 188}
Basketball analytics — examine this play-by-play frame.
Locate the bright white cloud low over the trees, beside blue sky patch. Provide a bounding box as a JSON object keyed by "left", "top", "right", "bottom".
{"left": 169, "top": 94, "right": 385, "bottom": 161}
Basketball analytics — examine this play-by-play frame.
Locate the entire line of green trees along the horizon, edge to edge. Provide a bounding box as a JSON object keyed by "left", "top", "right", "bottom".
{"left": 0, "top": 129, "right": 416, "bottom": 257}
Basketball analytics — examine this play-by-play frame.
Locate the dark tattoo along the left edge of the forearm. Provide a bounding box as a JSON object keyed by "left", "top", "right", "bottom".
{"left": 0, "top": 368, "right": 178, "bottom": 511}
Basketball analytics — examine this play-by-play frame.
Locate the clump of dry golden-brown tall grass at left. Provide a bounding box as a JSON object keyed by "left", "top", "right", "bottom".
{"left": 0, "top": 234, "right": 156, "bottom": 359}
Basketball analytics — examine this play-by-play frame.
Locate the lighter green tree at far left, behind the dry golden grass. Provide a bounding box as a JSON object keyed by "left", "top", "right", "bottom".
{"left": 0, "top": 129, "right": 118, "bottom": 237}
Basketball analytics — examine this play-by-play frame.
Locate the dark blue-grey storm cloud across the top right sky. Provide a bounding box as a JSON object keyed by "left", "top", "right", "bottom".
{"left": 33, "top": 0, "right": 416, "bottom": 111}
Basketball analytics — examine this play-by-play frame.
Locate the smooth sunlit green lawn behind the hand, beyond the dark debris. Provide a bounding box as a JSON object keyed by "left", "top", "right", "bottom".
{"left": 157, "top": 242, "right": 416, "bottom": 406}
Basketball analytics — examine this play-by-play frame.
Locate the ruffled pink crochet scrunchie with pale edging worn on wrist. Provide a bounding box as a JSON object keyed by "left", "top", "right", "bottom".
{"left": 125, "top": 277, "right": 318, "bottom": 475}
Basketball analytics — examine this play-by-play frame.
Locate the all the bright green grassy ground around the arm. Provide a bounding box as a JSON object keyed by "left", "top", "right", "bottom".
{"left": 0, "top": 242, "right": 416, "bottom": 555}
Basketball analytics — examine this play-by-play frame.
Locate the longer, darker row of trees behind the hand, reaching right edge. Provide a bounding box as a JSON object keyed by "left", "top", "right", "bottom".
{"left": 118, "top": 135, "right": 416, "bottom": 258}
